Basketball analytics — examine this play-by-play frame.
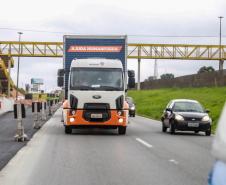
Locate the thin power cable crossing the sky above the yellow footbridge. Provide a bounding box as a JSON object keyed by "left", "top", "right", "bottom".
{"left": 0, "top": 27, "right": 226, "bottom": 38}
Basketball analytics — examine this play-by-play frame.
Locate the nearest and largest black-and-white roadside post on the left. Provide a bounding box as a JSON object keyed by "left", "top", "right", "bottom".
{"left": 14, "top": 104, "right": 27, "bottom": 141}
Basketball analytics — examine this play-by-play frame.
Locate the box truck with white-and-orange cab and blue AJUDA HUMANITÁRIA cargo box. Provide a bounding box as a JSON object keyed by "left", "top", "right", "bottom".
{"left": 58, "top": 35, "right": 135, "bottom": 134}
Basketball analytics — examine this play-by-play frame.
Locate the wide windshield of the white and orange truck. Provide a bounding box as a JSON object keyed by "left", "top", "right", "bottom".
{"left": 70, "top": 68, "right": 124, "bottom": 91}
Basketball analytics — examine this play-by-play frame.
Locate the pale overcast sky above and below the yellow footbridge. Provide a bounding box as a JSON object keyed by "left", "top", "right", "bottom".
{"left": 0, "top": 0, "right": 226, "bottom": 92}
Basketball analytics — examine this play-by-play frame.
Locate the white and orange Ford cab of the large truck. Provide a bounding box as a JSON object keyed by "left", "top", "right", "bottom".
{"left": 58, "top": 58, "right": 134, "bottom": 134}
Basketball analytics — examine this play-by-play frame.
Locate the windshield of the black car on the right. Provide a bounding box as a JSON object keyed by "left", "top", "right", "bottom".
{"left": 173, "top": 102, "right": 204, "bottom": 113}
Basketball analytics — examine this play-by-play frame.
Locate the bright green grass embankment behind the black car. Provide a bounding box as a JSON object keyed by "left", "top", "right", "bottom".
{"left": 128, "top": 87, "right": 226, "bottom": 133}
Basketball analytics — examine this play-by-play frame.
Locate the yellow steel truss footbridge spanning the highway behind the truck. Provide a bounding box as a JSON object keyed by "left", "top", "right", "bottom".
{"left": 0, "top": 41, "right": 226, "bottom": 90}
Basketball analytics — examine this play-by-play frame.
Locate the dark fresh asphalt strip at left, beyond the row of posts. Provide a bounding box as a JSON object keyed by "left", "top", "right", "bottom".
{"left": 0, "top": 107, "right": 56, "bottom": 170}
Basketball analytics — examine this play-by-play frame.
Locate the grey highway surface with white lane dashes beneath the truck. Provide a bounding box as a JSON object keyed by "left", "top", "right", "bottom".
{"left": 0, "top": 109, "right": 214, "bottom": 185}
